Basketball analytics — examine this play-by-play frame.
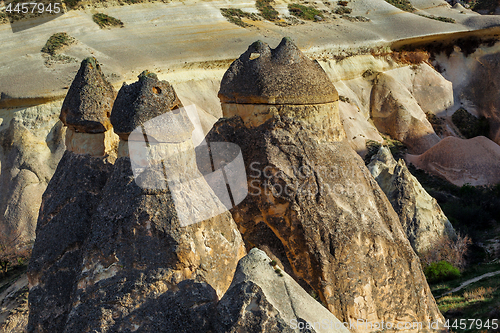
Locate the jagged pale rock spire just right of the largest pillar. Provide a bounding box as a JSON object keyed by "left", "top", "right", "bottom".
{"left": 368, "top": 146, "right": 456, "bottom": 254}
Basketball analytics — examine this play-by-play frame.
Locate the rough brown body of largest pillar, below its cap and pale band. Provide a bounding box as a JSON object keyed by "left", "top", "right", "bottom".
{"left": 207, "top": 38, "right": 443, "bottom": 331}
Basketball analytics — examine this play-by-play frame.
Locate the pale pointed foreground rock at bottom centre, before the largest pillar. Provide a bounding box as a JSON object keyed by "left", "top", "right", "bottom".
{"left": 216, "top": 248, "right": 349, "bottom": 333}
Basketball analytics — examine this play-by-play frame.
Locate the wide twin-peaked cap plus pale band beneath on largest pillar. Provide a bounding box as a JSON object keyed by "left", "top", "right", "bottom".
{"left": 219, "top": 38, "right": 345, "bottom": 141}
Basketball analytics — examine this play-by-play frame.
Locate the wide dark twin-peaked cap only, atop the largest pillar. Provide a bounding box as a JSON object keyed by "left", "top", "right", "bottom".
{"left": 219, "top": 38, "right": 338, "bottom": 105}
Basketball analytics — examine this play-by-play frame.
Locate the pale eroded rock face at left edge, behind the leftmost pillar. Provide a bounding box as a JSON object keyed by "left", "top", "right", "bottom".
{"left": 0, "top": 102, "right": 64, "bottom": 240}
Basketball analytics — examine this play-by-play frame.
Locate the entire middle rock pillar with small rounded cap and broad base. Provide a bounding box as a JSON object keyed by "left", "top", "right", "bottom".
{"left": 64, "top": 72, "right": 245, "bottom": 333}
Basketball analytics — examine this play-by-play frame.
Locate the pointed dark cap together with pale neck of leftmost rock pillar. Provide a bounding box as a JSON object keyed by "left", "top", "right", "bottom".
{"left": 59, "top": 58, "right": 118, "bottom": 156}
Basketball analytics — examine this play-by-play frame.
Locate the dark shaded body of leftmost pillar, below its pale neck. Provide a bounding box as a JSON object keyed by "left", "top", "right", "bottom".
{"left": 28, "top": 151, "right": 112, "bottom": 333}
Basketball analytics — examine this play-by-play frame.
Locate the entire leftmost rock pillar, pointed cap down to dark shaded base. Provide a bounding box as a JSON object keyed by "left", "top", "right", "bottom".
{"left": 28, "top": 58, "right": 117, "bottom": 333}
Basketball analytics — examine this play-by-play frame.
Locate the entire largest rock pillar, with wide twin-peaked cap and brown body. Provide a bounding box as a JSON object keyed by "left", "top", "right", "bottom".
{"left": 207, "top": 39, "right": 442, "bottom": 331}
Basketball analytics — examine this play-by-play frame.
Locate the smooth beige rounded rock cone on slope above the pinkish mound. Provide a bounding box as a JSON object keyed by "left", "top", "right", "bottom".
{"left": 370, "top": 73, "right": 440, "bottom": 154}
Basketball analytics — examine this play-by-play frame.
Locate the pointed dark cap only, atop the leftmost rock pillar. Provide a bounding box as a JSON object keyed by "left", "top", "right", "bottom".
{"left": 59, "top": 58, "right": 116, "bottom": 133}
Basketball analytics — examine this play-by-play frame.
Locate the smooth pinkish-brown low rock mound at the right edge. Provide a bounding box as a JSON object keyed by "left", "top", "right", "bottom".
{"left": 406, "top": 136, "right": 500, "bottom": 186}
